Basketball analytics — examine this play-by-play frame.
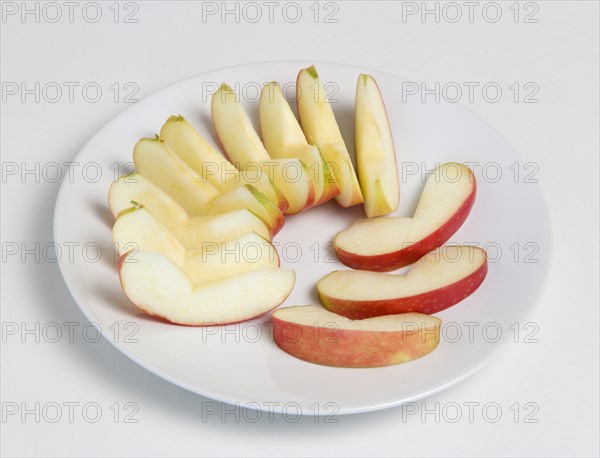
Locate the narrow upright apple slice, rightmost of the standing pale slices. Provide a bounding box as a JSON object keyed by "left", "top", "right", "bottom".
{"left": 354, "top": 74, "right": 400, "bottom": 218}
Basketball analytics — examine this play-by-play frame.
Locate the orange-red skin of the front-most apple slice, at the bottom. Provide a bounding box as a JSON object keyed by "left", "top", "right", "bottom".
{"left": 273, "top": 316, "right": 441, "bottom": 368}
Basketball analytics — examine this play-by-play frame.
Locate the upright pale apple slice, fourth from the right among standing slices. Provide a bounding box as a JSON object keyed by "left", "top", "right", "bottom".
{"left": 211, "top": 84, "right": 315, "bottom": 214}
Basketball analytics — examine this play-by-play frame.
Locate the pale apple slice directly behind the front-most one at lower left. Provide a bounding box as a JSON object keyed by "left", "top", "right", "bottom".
{"left": 112, "top": 207, "right": 279, "bottom": 283}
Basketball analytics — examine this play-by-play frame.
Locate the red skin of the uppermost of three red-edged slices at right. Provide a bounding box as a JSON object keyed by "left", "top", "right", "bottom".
{"left": 334, "top": 180, "right": 477, "bottom": 272}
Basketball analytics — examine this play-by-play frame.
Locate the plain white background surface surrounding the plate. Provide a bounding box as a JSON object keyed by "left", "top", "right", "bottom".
{"left": 0, "top": 1, "right": 600, "bottom": 456}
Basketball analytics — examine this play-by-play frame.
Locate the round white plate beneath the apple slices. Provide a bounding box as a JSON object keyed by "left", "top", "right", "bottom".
{"left": 54, "top": 62, "right": 551, "bottom": 415}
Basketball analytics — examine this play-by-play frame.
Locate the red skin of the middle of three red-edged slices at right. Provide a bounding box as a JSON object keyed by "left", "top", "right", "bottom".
{"left": 319, "top": 259, "right": 488, "bottom": 320}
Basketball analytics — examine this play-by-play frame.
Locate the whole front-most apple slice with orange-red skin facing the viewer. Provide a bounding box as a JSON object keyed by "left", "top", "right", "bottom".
{"left": 273, "top": 305, "right": 441, "bottom": 367}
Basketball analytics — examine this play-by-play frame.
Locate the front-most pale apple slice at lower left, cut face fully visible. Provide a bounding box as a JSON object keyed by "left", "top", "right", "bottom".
{"left": 119, "top": 251, "right": 295, "bottom": 326}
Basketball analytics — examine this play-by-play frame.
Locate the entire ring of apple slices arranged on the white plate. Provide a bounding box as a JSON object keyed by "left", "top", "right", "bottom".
{"left": 109, "top": 66, "right": 488, "bottom": 367}
